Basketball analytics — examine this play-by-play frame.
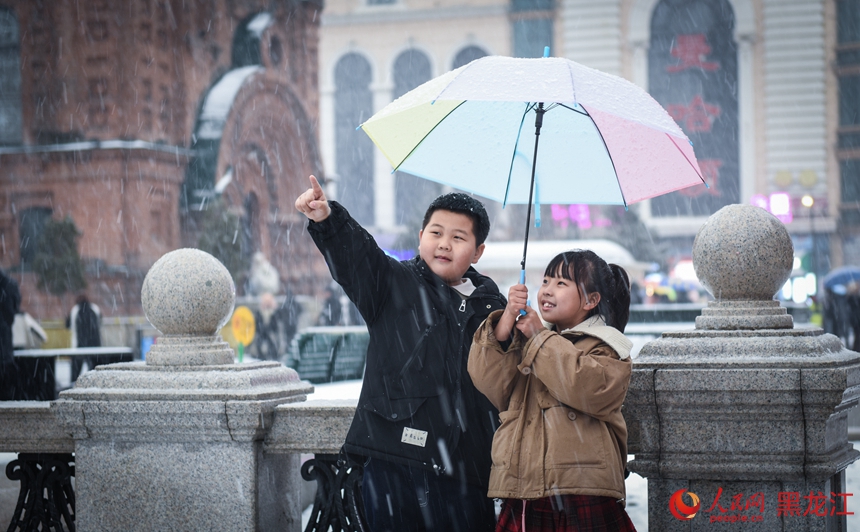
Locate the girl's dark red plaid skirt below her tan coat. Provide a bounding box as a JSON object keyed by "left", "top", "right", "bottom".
{"left": 496, "top": 495, "right": 636, "bottom": 532}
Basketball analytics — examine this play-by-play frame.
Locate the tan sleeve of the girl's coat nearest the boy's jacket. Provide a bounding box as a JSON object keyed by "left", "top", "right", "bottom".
{"left": 468, "top": 310, "right": 523, "bottom": 411}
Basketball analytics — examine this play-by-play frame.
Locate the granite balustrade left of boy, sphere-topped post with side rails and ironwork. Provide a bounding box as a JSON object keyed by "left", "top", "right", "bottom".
{"left": 0, "top": 249, "right": 361, "bottom": 532}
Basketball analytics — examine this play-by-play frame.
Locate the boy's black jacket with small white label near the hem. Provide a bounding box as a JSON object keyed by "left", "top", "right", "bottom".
{"left": 308, "top": 201, "right": 505, "bottom": 486}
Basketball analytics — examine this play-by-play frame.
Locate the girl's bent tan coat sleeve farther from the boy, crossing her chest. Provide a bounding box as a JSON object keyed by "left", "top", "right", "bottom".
{"left": 521, "top": 331, "right": 632, "bottom": 419}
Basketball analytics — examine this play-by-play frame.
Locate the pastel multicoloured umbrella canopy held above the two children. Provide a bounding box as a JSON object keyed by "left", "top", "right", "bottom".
{"left": 361, "top": 56, "right": 704, "bottom": 206}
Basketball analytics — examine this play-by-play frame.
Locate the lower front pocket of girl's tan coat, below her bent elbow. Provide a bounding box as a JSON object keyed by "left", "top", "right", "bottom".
{"left": 544, "top": 406, "right": 610, "bottom": 469}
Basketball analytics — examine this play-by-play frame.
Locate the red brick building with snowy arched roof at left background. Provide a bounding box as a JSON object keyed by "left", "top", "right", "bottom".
{"left": 0, "top": 0, "right": 325, "bottom": 318}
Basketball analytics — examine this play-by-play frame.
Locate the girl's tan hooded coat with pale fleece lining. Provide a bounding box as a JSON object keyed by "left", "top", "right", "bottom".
{"left": 469, "top": 311, "right": 632, "bottom": 499}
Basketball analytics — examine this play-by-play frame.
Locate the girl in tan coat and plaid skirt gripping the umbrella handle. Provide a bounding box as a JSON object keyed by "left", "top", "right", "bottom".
{"left": 469, "top": 250, "right": 635, "bottom": 532}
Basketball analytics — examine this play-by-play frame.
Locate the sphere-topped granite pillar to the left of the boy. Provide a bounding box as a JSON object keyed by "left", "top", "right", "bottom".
{"left": 53, "top": 249, "right": 313, "bottom": 532}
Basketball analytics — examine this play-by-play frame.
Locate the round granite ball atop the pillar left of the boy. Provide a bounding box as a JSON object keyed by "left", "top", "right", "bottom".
{"left": 141, "top": 248, "right": 236, "bottom": 336}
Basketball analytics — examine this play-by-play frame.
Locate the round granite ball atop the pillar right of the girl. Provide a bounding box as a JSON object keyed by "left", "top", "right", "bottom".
{"left": 693, "top": 205, "right": 794, "bottom": 301}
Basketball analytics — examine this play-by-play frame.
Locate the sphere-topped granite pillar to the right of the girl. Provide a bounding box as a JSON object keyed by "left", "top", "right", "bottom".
{"left": 624, "top": 205, "right": 860, "bottom": 532}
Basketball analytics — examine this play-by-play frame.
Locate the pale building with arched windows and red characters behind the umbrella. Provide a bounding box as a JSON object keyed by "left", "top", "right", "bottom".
{"left": 320, "top": 0, "right": 860, "bottom": 294}
